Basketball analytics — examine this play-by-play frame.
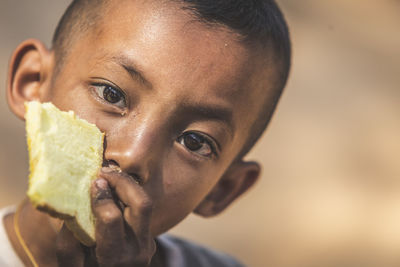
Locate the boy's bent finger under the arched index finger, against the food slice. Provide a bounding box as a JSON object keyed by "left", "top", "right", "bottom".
{"left": 92, "top": 178, "right": 125, "bottom": 259}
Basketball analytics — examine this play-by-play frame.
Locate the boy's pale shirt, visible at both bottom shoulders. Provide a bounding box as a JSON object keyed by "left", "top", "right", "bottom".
{"left": 0, "top": 207, "right": 243, "bottom": 267}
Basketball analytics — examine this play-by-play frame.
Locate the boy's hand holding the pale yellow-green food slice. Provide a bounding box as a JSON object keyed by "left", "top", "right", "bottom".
{"left": 57, "top": 168, "right": 156, "bottom": 266}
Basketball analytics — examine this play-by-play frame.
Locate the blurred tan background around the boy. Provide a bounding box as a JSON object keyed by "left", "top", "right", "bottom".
{"left": 0, "top": 0, "right": 400, "bottom": 267}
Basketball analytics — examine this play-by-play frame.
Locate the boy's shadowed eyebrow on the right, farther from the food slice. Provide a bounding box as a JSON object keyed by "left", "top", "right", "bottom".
{"left": 181, "top": 103, "right": 235, "bottom": 136}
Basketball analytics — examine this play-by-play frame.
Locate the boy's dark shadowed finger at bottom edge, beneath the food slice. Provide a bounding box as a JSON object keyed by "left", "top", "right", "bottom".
{"left": 56, "top": 224, "right": 85, "bottom": 267}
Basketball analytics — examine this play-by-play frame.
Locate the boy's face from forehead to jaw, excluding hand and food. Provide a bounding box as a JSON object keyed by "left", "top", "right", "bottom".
{"left": 10, "top": 1, "right": 273, "bottom": 236}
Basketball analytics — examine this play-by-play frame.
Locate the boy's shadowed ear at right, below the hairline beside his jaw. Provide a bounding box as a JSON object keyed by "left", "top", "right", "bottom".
{"left": 194, "top": 160, "right": 261, "bottom": 217}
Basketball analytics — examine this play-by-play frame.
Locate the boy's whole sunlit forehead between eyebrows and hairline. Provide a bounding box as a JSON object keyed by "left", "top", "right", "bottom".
{"left": 66, "top": 0, "right": 278, "bottom": 140}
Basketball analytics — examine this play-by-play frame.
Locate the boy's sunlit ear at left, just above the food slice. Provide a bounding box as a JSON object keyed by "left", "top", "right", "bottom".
{"left": 7, "top": 39, "right": 52, "bottom": 119}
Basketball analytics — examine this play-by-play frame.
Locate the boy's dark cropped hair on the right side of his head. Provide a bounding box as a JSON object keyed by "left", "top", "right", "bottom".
{"left": 178, "top": 0, "right": 291, "bottom": 158}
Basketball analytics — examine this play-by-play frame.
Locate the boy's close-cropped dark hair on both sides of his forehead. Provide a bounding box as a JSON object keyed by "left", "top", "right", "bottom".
{"left": 52, "top": 0, "right": 291, "bottom": 157}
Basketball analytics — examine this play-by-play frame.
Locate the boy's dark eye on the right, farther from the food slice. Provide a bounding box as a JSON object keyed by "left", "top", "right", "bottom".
{"left": 178, "top": 132, "right": 216, "bottom": 157}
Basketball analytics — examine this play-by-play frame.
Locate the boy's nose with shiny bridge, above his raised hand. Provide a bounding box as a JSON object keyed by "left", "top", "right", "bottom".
{"left": 104, "top": 116, "right": 164, "bottom": 183}
